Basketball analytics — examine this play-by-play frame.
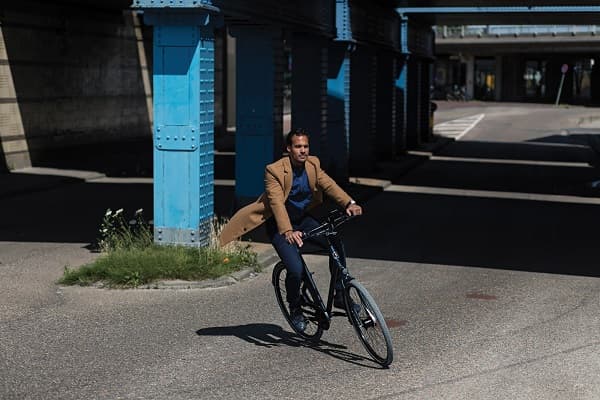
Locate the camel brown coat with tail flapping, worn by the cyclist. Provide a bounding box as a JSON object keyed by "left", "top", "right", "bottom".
{"left": 219, "top": 156, "right": 351, "bottom": 246}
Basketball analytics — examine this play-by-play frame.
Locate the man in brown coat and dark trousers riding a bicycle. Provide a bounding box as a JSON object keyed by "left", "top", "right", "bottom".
{"left": 219, "top": 129, "right": 362, "bottom": 331}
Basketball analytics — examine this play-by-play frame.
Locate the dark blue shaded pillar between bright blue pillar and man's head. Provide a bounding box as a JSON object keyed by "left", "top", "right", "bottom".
{"left": 231, "top": 25, "right": 285, "bottom": 204}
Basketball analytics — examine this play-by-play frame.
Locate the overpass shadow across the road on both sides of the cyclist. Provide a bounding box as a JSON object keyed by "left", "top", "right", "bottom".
{"left": 0, "top": 134, "right": 600, "bottom": 276}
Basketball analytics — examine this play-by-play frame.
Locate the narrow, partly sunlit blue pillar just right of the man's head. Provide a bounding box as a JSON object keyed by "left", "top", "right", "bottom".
{"left": 327, "top": 0, "right": 355, "bottom": 183}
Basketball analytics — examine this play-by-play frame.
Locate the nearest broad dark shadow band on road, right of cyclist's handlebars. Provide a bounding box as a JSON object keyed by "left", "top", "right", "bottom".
{"left": 344, "top": 192, "right": 600, "bottom": 276}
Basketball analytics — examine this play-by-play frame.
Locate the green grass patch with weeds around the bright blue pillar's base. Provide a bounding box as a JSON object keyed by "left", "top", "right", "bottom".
{"left": 59, "top": 210, "right": 259, "bottom": 288}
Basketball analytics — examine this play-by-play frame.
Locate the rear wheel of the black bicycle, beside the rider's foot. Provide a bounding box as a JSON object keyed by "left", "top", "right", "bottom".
{"left": 272, "top": 261, "right": 323, "bottom": 342}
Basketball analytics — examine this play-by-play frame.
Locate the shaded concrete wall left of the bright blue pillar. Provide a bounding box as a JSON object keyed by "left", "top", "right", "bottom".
{"left": 0, "top": 1, "right": 152, "bottom": 169}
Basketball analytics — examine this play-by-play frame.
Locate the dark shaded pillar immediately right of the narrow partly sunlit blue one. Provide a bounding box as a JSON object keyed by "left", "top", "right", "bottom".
{"left": 350, "top": 45, "right": 377, "bottom": 174}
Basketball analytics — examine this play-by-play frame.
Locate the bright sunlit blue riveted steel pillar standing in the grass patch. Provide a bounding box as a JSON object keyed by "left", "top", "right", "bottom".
{"left": 133, "top": 0, "right": 218, "bottom": 245}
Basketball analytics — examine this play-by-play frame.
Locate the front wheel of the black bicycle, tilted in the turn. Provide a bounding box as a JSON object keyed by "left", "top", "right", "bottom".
{"left": 346, "top": 281, "right": 394, "bottom": 367}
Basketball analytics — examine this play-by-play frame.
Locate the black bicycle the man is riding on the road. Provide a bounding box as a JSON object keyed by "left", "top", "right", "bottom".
{"left": 272, "top": 210, "right": 394, "bottom": 367}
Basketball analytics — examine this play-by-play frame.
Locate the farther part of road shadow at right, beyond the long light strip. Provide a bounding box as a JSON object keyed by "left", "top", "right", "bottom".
{"left": 418, "top": 139, "right": 600, "bottom": 197}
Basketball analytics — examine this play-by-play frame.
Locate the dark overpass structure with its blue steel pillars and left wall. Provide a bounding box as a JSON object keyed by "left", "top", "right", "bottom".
{"left": 0, "top": 0, "right": 600, "bottom": 244}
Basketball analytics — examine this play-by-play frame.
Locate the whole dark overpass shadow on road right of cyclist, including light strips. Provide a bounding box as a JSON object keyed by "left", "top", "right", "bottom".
{"left": 345, "top": 142, "right": 600, "bottom": 276}
